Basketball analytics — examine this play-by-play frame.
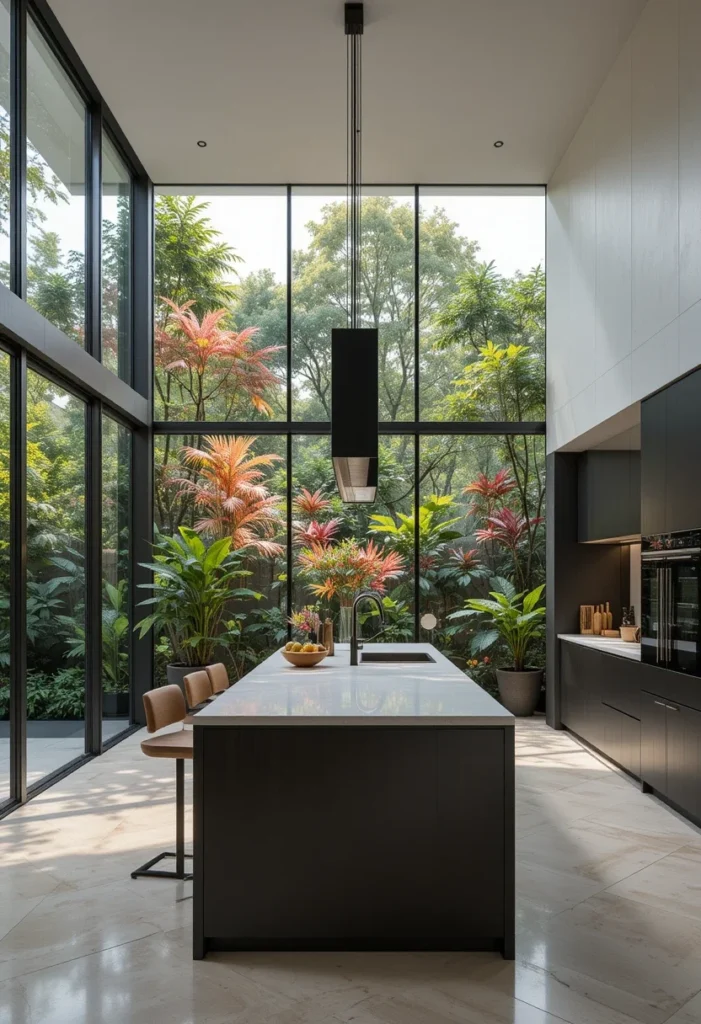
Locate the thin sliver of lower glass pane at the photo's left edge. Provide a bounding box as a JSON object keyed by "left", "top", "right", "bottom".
{"left": 0, "top": 351, "right": 10, "bottom": 804}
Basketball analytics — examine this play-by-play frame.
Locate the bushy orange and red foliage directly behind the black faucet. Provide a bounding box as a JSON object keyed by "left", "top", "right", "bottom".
{"left": 297, "top": 538, "right": 404, "bottom": 605}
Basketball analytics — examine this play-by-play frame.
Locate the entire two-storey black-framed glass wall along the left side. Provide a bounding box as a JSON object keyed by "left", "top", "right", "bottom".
{"left": 0, "top": 0, "right": 143, "bottom": 815}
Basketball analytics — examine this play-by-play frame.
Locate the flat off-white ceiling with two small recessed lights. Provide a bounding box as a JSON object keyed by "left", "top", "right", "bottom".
{"left": 51, "top": 0, "right": 645, "bottom": 183}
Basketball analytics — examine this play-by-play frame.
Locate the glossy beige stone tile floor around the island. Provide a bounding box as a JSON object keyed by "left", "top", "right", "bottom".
{"left": 0, "top": 720, "right": 701, "bottom": 1024}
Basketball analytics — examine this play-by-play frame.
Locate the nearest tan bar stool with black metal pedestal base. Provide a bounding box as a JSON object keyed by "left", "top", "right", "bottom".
{"left": 131, "top": 673, "right": 191, "bottom": 881}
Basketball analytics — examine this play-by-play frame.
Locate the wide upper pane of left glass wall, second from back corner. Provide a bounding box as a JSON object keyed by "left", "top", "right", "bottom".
{"left": 27, "top": 17, "right": 86, "bottom": 345}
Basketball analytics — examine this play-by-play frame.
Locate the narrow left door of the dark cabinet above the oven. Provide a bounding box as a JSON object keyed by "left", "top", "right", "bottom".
{"left": 641, "top": 389, "right": 667, "bottom": 537}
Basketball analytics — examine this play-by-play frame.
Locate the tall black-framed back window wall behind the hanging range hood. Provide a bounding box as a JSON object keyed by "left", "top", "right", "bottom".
{"left": 155, "top": 185, "right": 544, "bottom": 687}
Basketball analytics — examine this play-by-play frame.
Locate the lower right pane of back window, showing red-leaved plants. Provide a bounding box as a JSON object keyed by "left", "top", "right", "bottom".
{"left": 420, "top": 435, "right": 545, "bottom": 693}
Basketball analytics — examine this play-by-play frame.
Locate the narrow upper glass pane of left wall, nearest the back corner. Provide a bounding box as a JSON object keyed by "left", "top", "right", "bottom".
{"left": 102, "top": 133, "right": 131, "bottom": 381}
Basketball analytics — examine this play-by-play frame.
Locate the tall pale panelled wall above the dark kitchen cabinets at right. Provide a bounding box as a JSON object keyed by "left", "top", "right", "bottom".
{"left": 547, "top": 0, "right": 701, "bottom": 451}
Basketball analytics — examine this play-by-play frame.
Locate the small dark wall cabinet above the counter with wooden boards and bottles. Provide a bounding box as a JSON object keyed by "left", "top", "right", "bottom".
{"left": 578, "top": 452, "right": 641, "bottom": 543}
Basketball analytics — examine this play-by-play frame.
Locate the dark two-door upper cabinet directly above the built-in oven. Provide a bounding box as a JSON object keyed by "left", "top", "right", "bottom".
{"left": 641, "top": 370, "right": 701, "bottom": 536}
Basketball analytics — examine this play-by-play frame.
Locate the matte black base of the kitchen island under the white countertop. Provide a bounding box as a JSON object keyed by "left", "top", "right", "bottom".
{"left": 193, "top": 725, "right": 514, "bottom": 959}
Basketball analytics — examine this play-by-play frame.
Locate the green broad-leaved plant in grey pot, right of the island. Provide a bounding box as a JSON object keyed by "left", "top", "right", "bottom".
{"left": 454, "top": 579, "right": 545, "bottom": 717}
